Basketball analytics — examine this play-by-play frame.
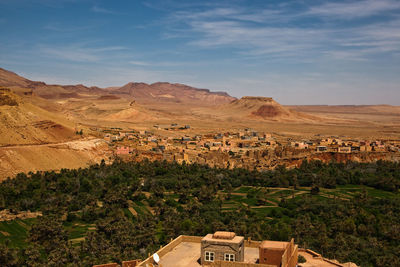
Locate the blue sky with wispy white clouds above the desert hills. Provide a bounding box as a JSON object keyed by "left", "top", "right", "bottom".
{"left": 0, "top": 0, "right": 400, "bottom": 105}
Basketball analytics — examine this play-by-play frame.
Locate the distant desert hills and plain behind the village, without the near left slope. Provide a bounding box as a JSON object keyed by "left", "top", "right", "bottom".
{"left": 0, "top": 66, "right": 400, "bottom": 132}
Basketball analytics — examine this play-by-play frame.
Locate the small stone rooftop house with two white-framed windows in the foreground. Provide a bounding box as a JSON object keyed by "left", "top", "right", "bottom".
{"left": 201, "top": 232, "right": 244, "bottom": 265}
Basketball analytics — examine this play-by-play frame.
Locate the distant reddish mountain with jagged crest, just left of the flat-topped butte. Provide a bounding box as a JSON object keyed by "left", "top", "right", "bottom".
{"left": 110, "top": 82, "right": 236, "bottom": 105}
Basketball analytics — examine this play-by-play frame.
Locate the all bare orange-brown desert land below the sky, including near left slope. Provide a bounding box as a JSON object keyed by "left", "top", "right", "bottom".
{"left": 0, "top": 69, "right": 400, "bottom": 179}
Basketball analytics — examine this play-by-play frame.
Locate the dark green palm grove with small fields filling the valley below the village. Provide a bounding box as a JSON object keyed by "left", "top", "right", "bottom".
{"left": 0, "top": 161, "right": 400, "bottom": 266}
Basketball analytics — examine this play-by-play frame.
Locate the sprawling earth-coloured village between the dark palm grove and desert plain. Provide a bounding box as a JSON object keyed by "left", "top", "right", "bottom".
{"left": 96, "top": 123, "right": 400, "bottom": 170}
